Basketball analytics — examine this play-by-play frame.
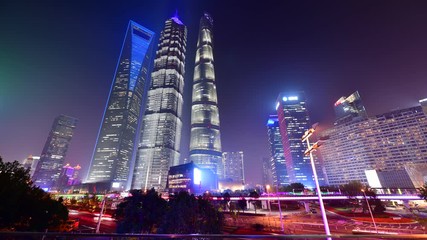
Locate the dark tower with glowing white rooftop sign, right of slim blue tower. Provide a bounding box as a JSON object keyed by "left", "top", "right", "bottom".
{"left": 277, "top": 92, "right": 326, "bottom": 188}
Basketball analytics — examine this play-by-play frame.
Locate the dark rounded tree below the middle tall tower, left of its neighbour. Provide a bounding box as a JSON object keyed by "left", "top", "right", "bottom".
{"left": 115, "top": 189, "right": 167, "bottom": 233}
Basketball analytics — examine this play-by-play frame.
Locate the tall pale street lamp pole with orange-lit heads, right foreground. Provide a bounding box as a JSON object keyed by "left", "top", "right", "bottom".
{"left": 301, "top": 124, "right": 332, "bottom": 240}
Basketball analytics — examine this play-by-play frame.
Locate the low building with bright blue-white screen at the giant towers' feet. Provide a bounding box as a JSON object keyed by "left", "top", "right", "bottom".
{"left": 167, "top": 162, "right": 218, "bottom": 195}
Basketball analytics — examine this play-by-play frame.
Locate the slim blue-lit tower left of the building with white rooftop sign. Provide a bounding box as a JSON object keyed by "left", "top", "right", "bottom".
{"left": 266, "top": 115, "right": 290, "bottom": 186}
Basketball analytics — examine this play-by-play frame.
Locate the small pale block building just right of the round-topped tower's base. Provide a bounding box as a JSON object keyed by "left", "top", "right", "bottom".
{"left": 221, "top": 151, "right": 245, "bottom": 185}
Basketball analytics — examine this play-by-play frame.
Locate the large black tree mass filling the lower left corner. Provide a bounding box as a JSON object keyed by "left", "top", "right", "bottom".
{"left": 0, "top": 157, "right": 68, "bottom": 231}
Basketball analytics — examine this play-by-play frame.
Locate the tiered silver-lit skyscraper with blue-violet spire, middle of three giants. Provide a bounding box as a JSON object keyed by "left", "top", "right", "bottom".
{"left": 132, "top": 15, "right": 187, "bottom": 190}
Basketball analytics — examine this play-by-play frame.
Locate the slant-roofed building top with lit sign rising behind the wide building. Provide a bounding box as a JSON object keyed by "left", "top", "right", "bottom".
{"left": 334, "top": 91, "right": 368, "bottom": 125}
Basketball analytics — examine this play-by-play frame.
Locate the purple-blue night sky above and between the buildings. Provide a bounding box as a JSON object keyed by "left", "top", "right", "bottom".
{"left": 0, "top": 0, "right": 427, "bottom": 183}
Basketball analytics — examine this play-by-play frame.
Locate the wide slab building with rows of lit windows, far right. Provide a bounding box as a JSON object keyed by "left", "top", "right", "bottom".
{"left": 319, "top": 101, "right": 427, "bottom": 187}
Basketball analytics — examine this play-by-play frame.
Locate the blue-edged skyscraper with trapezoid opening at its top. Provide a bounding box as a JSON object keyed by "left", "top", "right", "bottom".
{"left": 86, "top": 21, "right": 154, "bottom": 190}
